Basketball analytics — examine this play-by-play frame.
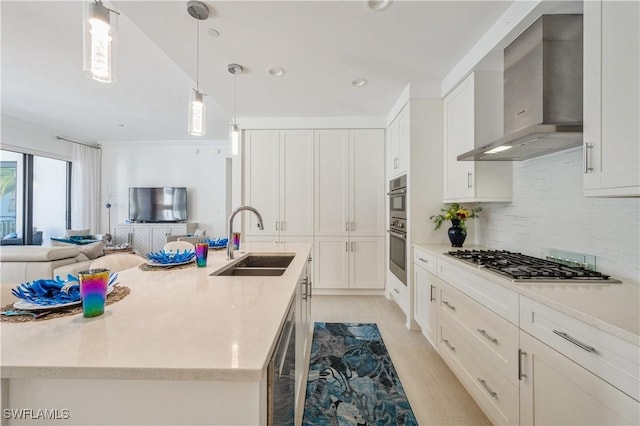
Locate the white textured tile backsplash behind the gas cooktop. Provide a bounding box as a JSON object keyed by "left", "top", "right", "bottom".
{"left": 475, "top": 149, "right": 640, "bottom": 282}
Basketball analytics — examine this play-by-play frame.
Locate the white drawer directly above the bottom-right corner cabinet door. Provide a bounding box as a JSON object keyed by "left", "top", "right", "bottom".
{"left": 520, "top": 297, "right": 640, "bottom": 401}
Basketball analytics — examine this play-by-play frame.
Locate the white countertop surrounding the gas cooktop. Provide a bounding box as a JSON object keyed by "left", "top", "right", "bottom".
{"left": 414, "top": 244, "right": 640, "bottom": 345}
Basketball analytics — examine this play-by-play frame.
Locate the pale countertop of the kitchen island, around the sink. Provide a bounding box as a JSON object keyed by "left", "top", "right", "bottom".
{"left": 0, "top": 243, "right": 311, "bottom": 381}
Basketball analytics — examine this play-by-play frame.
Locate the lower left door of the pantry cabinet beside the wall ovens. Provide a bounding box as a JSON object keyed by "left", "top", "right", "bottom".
{"left": 313, "top": 237, "right": 349, "bottom": 289}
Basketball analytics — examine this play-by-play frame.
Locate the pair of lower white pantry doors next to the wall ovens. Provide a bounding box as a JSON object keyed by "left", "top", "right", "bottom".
{"left": 314, "top": 236, "right": 385, "bottom": 290}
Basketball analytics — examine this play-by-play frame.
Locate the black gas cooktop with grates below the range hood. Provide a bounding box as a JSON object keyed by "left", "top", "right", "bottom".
{"left": 448, "top": 250, "right": 620, "bottom": 284}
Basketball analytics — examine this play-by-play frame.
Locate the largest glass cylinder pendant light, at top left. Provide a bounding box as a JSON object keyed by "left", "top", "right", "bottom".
{"left": 82, "top": 0, "right": 119, "bottom": 83}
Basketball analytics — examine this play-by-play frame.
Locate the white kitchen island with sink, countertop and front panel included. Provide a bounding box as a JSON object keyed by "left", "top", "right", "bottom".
{"left": 1, "top": 243, "right": 311, "bottom": 425}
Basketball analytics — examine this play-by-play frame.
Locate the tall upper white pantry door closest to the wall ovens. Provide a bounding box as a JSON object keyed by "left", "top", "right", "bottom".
{"left": 349, "top": 130, "right": 385, "bottom": 236}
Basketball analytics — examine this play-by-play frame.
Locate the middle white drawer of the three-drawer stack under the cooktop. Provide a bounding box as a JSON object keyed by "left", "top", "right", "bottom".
{"left": 440, "top": 284, "right": 519, "bottom": 384}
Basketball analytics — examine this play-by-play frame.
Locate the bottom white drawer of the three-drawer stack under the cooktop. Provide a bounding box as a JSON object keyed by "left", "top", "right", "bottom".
{"left": 438, "top": 316, "right": 519, "bottom": 425}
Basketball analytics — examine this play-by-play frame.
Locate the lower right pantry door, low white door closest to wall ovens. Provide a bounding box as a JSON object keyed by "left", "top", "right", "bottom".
{"left": 349, "top": 237, "right": 385, "bottom": 289}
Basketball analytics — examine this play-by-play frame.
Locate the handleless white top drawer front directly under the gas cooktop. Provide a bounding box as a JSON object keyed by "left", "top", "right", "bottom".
{"left": 438, "top": 259, "right": 519, "bottom": 325}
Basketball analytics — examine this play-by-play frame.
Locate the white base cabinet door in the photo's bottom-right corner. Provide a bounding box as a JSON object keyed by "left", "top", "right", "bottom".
{"left": 520, "top": 332, "right": 640, "bottom": 425}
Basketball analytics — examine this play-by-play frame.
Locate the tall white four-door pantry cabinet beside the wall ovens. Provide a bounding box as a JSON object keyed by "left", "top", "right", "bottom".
{"left": 314, "top": 129, "right": 385, "bottom": 289}
